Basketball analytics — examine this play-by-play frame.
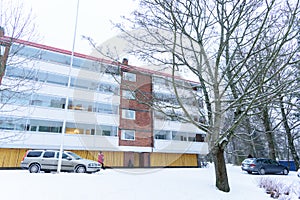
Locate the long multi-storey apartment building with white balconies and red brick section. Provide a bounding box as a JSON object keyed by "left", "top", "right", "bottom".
{"left": 0, "top": 38, "right": 208, "bottom": 167}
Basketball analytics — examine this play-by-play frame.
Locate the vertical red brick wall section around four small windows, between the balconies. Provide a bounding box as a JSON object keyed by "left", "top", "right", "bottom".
{"left": 119, "top": 68, "right": 153, "bottom": 147}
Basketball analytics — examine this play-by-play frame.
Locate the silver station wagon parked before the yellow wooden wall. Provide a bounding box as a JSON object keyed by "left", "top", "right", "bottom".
{"left": 21, "top": 150, "right": 101, "bottom": 173}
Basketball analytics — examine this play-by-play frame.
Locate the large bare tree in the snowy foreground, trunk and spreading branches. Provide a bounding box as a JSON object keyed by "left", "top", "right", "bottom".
{"left": 88, "top": 0, "right": 299, "bottom": 192}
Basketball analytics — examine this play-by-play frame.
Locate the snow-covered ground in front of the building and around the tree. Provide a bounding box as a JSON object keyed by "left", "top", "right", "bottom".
{"left": 0, "top": 165, "right": 300, "bottom": 200}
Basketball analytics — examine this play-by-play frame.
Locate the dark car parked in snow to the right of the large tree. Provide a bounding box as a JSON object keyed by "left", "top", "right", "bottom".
{"left": 241, "top": 158, "right": 289, "bottom": 175}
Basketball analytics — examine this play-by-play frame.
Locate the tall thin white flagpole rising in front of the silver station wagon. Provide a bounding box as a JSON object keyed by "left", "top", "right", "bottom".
{"left": 57, "top": 0, "right": 79, "bottom": 173}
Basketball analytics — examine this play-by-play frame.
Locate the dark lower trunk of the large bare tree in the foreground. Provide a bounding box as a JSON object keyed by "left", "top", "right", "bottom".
{"left": 212, "top": 146, "right": 230, "bottom": 192}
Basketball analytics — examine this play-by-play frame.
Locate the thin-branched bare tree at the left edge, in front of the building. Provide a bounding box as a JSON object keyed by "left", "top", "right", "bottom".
{"left": 0, "top": 0, "right": 40, "bottom": 142}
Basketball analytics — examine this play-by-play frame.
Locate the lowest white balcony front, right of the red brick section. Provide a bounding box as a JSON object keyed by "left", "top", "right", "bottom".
{"left": 153, "top": 140, "right": 208, "bottom": 154}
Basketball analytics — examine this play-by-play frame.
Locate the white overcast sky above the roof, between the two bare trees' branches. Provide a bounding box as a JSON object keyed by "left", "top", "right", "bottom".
{"left": 24, "top": 0, "right": 137, "bottom": 54}
